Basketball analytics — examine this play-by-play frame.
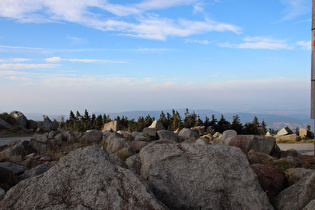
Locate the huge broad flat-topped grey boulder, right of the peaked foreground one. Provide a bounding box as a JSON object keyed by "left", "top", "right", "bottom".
{"left": 139, "top": 141, "right": 272, "bottom": 209}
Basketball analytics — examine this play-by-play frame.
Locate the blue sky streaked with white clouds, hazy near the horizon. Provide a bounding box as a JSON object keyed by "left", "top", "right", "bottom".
{"left": 0, "top": 0, "right": 311, "bottom": 114}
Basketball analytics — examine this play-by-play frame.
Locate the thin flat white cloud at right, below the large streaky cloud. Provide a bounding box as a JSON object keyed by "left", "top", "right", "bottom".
{"left": 219, "top": 37, "right": 293, "bottom": 50}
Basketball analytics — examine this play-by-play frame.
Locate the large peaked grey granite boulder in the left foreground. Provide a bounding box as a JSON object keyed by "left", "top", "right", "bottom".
{"left": 0, "top": 146, "right": 166, "bottom": 209}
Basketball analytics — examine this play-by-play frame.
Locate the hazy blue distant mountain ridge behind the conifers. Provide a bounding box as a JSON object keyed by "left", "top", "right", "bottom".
{"left": 25, "top": 109, "right": 314, "bottom": 130}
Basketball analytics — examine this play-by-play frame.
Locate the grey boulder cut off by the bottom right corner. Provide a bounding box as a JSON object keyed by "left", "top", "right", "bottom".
{"left": 273, "top": 173, "right": 315, "bottom": 210}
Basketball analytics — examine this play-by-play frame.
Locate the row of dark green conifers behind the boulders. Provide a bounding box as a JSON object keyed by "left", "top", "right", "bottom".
{"left": 65, "top": 108, "right": 266, "bottom": 135}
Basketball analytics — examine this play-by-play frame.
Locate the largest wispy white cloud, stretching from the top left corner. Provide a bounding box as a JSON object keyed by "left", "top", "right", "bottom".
{"left": 0, "top": 0, "right": 241, "bottom": 40}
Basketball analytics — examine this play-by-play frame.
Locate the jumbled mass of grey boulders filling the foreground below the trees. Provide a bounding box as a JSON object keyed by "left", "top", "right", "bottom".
{"left": 0, "top": 121, "right": 315, "bottom": 209}
